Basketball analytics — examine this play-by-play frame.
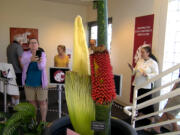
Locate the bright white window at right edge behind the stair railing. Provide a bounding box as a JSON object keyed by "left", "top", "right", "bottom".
{"left": 160, "top": 0, "right": 180, "bottom": 109}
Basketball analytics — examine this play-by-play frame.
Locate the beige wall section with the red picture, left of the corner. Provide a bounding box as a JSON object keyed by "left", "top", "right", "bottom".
{"left": 0, "top": 0, "right": 87, "bottom": 70}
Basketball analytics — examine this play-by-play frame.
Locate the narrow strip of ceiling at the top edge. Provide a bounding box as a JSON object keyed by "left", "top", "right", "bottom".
{"left": 44, "top": 0, "right": 93, "bottom": 6}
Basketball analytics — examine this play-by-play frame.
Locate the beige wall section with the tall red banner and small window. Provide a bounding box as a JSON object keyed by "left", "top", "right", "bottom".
{"left": 87, "top": 0, "right": 168, "bottom": 104}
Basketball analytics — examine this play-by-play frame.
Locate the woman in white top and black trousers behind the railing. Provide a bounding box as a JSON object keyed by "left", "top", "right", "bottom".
{"left": 128, "top": 46, "right": 159, "bottom": 115}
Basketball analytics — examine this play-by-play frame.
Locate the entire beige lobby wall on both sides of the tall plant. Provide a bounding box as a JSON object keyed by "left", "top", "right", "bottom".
{"left": 0, "top": 0, "right": 168, "bottom": 104}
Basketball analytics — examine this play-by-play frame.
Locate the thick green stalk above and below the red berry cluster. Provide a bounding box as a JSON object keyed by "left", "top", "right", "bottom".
{"left": 94, "top": 0, "right": 112, "bottom": 135}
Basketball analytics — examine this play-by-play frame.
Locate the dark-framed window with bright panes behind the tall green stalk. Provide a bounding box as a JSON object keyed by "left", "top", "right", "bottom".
{"left": 88, "top": 18, "right": 112, "bottom": 50}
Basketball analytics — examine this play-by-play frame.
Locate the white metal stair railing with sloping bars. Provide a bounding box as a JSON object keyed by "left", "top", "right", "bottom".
{"left": 124, "top": 64, "right": 180, "bottom": 135}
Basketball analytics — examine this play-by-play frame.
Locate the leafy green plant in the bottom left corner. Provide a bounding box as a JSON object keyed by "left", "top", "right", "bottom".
{"left": 0, "top": 102, "right": 47, "bottom": 135}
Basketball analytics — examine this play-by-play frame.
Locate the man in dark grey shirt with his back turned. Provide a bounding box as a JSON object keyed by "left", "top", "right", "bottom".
{"left": 7, "top": 35, "right": 23, "bottom": 105}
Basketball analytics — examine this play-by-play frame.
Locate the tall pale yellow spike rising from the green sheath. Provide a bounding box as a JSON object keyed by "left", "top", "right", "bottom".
{"left": 72, "top": 16, "right": 90, "bottom": 75}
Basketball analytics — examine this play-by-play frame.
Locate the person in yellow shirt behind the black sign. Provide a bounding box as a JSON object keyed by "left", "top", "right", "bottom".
{"left": 54, "top": 45, "right": 69, "bottom": 67}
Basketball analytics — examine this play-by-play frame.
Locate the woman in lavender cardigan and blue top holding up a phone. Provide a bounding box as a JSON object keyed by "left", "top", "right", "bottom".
{"left": 21, "top": 38, "right": 48, "bottom": 121}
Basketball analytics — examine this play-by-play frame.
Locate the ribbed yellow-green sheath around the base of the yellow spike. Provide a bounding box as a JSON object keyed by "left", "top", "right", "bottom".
{"left": 65, "top": 72, "right": 95, "bottom": 135}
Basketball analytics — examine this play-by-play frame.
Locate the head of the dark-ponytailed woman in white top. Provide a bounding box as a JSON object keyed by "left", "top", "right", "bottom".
{"left": 141, "top": 46, "right": 157, "bottom": 62}
